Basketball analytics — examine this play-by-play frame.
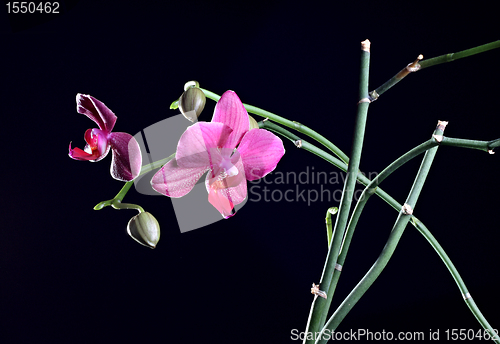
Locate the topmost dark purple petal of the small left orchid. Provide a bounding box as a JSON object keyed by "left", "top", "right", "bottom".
{"left": 76, "top": 93, "right": 116, "bottom": 133}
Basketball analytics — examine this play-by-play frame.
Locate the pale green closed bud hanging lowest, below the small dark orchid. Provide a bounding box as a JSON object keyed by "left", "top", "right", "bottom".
{"left": 127, "top": 212, "right": 160, "bottom": 248}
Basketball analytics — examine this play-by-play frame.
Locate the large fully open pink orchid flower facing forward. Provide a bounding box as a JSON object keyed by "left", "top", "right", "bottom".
{"left": 151, "top": 91, "right": 285, "bottom": 219}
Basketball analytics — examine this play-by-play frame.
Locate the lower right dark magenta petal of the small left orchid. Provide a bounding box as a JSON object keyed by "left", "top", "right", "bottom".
{"left": 108, "top": 133, "right": 142, "bottom": 182}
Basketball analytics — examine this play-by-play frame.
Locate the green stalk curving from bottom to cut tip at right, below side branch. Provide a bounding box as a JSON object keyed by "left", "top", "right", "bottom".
{"left": 316, "top": 125, "right": 440, "bottom": 344}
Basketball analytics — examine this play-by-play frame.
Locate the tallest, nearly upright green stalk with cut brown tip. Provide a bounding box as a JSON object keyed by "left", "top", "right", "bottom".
{"left": 304, "top": 40, "right": 370, "bottom": 344}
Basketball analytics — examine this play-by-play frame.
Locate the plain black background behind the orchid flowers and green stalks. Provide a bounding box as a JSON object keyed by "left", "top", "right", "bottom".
{"left": 0, "top": 0, "right": 500, "bottom": 343}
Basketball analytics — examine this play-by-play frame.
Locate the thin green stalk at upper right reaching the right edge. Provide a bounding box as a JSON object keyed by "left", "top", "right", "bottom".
{"left": 370, "top": 40, "right": 500, "bottom": 99}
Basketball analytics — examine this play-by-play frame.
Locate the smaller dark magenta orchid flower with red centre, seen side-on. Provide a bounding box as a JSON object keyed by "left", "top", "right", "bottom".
{"left": 69, "top": 93, "right": 142, "bottom": 182}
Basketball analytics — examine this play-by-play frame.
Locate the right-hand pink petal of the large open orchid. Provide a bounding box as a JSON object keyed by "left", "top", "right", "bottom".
{"left": 238, "top": 129, "right": 285, "bottom": 180}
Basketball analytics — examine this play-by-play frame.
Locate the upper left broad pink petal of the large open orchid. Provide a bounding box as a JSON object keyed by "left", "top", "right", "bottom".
{"left": 175, "top": 122, "right": 232, "bottom": 169}
